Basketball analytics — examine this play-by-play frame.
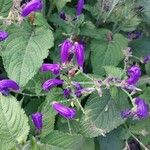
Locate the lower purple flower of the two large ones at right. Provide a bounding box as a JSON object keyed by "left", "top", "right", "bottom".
{"left": 133, "top": 97, "right": 149, "bottom": 119}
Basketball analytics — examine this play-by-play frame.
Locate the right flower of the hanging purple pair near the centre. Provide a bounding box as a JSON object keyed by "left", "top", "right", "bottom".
{"left": 74, "top": 42, "right": 84, "bottom": 68}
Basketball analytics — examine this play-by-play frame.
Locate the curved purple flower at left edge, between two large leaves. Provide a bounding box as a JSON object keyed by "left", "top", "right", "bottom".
{"left": 0, "top": 79, "right": 20, "bottom": 96}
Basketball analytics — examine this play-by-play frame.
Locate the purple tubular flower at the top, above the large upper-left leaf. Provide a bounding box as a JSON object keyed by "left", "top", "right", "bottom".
{"left": 21, "top": 0, "right": 42, "bottom": 17}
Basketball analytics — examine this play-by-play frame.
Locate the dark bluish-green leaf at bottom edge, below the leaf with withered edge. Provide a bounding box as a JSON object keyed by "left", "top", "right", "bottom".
{"left": 96, "top": 128, "right": 124, "bottom": 150}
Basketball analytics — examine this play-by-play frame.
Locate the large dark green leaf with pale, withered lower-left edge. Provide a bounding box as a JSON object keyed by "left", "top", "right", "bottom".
{"left": 81, "top": 91, "right": 127, "bottom": 137}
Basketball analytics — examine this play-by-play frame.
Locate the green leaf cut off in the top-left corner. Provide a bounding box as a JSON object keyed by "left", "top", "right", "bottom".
{"left": 0, "top": 0, "right": 13, "bottom": 17}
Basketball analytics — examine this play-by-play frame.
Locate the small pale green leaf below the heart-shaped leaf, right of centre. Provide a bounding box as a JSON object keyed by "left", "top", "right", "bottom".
{"left": 104, "top": 66, "right": 125, "bottom": 79}
